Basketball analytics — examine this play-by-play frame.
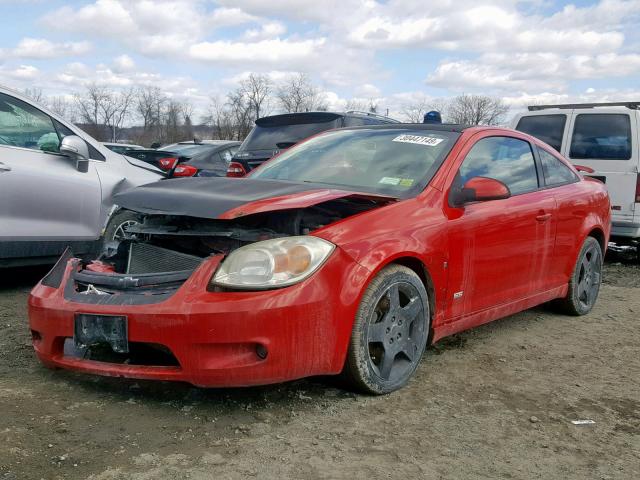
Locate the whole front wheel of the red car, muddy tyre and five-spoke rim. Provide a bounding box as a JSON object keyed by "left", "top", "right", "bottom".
{"left": 342, "top": 265, "right": 430, "bottom": 395}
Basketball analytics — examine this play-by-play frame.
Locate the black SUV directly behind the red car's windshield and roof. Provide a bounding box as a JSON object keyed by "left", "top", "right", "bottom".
{"left": 227, "top": 111, "right": 400, "bottom": 177}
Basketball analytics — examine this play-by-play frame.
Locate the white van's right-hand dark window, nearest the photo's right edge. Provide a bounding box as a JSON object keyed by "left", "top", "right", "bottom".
{"left": 569, "top": 113, "right": 631, "bottom": 160}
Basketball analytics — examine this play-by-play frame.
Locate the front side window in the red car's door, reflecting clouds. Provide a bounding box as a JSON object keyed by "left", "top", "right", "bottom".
{"left": 459, "top": 137, "right": 538, "bottom": 195}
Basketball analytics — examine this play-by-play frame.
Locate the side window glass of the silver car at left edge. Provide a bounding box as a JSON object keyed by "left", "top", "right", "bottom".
{"left": 0, "top": 93, "right": 60, "bottom": 153}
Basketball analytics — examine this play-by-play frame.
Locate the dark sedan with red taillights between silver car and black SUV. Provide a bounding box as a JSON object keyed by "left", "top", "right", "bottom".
{"left": 126, "top": 140, "right": 240, "bottom": 177}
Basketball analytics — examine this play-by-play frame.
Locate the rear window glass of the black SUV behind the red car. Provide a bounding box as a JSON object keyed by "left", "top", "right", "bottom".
{"left": 240, "top": 120, "right": 338, "bottom": 151}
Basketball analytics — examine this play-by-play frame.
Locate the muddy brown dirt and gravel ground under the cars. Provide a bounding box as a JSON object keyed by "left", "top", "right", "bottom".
{"left": 0, "top": 262, "right": 640, "bottom": 480}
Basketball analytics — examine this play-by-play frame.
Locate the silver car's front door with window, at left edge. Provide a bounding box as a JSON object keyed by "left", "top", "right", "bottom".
{"left": 0, "top": 93, "right": 101, "bottom": 258}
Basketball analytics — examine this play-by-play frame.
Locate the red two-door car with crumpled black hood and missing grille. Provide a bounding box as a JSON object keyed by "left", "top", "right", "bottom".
{"left": 29, "top": 124, "right": 610, "bottom": 394}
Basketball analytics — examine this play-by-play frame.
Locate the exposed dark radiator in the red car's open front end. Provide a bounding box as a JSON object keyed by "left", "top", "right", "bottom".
{"left": 127, "top": 243, "right": 203, "bottom": 274}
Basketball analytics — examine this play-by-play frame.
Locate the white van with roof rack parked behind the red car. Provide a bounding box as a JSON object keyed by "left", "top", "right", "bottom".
{"left": 512, "top": 102, "right": 640, "bottom": 255}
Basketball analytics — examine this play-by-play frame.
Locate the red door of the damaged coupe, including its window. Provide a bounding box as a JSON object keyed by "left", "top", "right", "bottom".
{"left": 448, "top": 134, "right": 556, "bottom": 317}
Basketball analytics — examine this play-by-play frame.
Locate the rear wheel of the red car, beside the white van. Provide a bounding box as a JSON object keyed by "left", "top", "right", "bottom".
{"left": 554, "top": 237, "right": 602, "bottom": 315}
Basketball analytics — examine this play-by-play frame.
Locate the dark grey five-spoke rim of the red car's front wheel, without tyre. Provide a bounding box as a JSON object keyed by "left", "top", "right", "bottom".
{"left": 367, "top": 282, "right": 426, "bottom": 382}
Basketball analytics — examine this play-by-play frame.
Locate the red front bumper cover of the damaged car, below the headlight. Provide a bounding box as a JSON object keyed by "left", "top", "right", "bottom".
{"left": 29, "top": 248, "right": 368, "bottom": 387}
